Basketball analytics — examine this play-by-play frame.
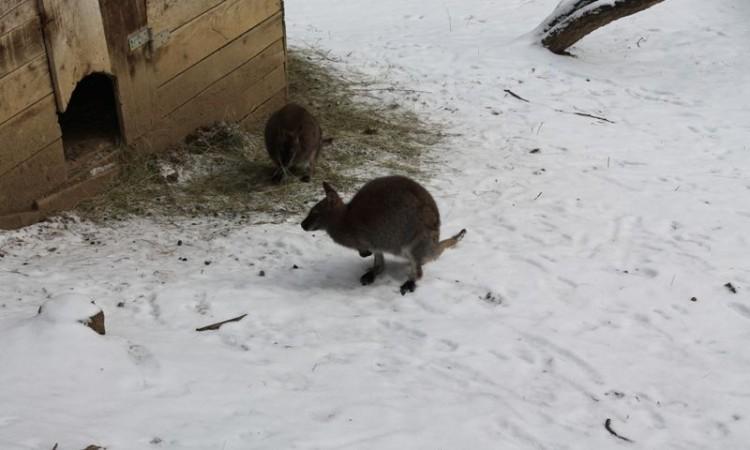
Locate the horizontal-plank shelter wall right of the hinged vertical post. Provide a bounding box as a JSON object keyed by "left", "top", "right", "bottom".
{"left": 139, "top": 0, "right": 286, "bottom": 150}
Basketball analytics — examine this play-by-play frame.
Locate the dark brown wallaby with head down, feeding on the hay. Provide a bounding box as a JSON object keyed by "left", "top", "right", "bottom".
{"left": 265, "top": 103, "right": 322, "bottom": 183}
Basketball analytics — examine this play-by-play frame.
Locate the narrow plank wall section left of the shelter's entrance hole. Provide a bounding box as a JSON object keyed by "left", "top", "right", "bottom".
{"left": 0, "top": 0, "right": 67, "bottom": 214}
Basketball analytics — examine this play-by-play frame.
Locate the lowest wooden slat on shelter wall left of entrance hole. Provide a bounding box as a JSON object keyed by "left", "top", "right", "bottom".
{"left": 0, "top": 139, "right": 67, "bottom": 214}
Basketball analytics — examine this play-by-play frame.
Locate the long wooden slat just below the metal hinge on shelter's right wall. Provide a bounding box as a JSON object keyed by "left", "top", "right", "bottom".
{"left": 155, "top": 0, "right": 281, "bottom": 86}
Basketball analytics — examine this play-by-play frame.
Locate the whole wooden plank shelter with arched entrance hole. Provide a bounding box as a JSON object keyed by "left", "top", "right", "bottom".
{"left": 0, "top": 0, "right": 287, "bottom": 228}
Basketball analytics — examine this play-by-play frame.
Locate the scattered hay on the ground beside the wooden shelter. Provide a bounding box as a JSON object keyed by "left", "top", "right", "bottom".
{"left": 78, "top": 49, "right": 440, "bottom": 221}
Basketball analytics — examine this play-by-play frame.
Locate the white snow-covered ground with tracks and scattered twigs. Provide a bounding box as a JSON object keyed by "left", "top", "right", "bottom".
{"left": 0, "top": 0, "right": 750, "bottom": 450}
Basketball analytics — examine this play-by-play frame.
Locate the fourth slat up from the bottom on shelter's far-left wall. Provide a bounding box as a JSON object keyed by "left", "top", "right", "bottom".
{"left": 0, "top": 13, "right": 44, "bottom": 82}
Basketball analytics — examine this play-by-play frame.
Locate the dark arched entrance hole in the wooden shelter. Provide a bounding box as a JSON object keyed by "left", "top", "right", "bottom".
{"left": 59, "top": 73, "right": 122, "bottom": 163}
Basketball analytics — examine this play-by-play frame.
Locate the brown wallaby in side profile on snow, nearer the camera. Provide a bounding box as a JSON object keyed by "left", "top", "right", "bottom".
{"left": 302, "top": 176, "right": 466, "bottom": 295}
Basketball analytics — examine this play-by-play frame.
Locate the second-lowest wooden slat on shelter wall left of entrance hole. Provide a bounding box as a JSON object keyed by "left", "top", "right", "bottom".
{"left": 0, "top": 94, "right": 61, "bottom": 177}
